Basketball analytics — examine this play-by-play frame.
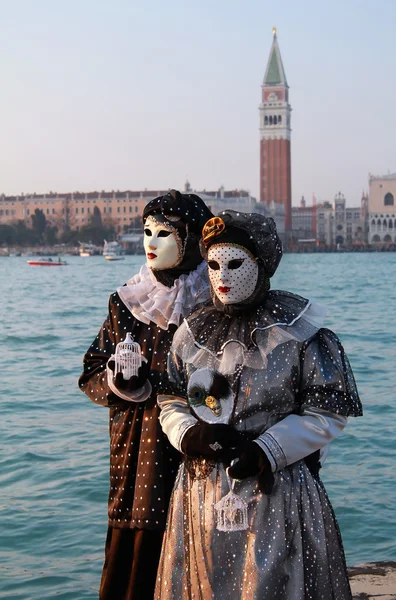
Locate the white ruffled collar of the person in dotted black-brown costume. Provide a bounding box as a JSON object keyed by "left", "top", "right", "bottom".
{"left": 117, "top": 261, "right": 210, "bottom": 330}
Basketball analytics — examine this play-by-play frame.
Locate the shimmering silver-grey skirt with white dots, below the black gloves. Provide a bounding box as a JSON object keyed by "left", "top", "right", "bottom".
{"left": 154, "top": 461, "right": 352, "bottom": 600}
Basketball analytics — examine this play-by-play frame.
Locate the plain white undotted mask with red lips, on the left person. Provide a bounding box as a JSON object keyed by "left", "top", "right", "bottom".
{"left": 143, "top": 216, "right": 183, "bottom": 271}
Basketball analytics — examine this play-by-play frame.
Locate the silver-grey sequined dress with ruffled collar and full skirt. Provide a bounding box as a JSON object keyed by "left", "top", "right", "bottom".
{"left": 155, "top": 291, "right": 362, "bottom": 600}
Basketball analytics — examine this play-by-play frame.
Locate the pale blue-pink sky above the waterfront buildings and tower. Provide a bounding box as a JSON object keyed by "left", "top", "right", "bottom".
{"left": 0, "top": 0, "right": 396, "bottom": 206}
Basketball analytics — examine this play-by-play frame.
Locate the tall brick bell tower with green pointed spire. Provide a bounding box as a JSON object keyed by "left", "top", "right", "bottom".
{"left": 259, "top": 27, "right": 292, "bottom": 236}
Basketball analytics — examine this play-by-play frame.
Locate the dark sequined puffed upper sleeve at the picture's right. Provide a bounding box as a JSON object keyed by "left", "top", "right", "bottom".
{"left": 298, "top": 329, "right": 363, "bottom": 417}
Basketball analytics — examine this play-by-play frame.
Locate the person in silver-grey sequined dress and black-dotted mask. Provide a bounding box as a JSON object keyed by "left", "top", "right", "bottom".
{"left": 155, "top": 210, "right": 362, "bottom": 600}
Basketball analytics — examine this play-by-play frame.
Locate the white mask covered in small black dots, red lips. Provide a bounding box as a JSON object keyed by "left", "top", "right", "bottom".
{"left": 207, "top": 244, "right": 259, "bottom": 304}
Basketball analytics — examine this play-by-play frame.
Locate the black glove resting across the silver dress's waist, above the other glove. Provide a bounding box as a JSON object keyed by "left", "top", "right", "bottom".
{"left": 181, "top": 422, "right": 241, "bottom": 461}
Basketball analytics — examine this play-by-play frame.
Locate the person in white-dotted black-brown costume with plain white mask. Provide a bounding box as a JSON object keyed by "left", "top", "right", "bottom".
{"left": 79, "top": 190, "right": 211, "bottom": 600}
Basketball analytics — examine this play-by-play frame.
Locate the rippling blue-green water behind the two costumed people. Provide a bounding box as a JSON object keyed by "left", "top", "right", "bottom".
{"left": 0, "top": 253, "right": 396, "bottom": 600}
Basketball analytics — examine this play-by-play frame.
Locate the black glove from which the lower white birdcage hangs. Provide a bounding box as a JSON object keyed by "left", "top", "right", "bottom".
{"left": 227, "top": 442, "right": 274, "bottom": 494}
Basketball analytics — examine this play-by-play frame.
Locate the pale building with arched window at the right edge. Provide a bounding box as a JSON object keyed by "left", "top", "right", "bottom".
{"left": 368, "top": 173, "right": 396, "bottom": 245}
